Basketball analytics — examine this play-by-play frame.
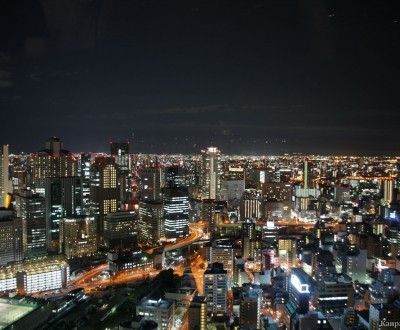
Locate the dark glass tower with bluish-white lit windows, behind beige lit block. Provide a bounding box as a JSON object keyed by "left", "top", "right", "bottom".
{"left": 45, "top": 176, "right": 82, "bottom": 251}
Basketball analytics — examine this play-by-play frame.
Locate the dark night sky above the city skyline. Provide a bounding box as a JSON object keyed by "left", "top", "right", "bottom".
{"left": 0, "top": 0, "right": 400, "bottom": 155}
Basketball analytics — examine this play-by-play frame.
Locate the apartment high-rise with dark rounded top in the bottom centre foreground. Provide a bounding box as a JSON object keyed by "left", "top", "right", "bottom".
{"left": 203, "top": 262, "right": 228, "bottom": 314}
